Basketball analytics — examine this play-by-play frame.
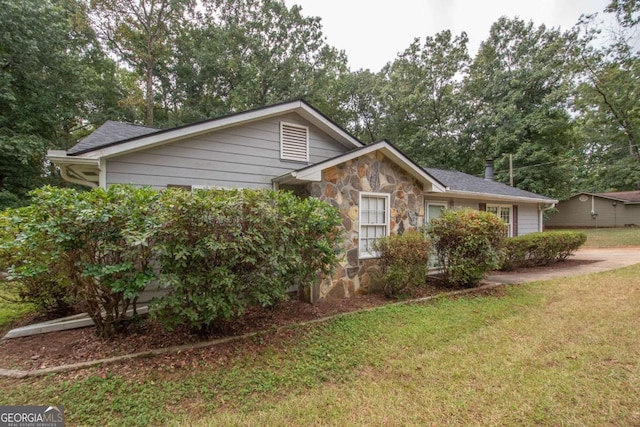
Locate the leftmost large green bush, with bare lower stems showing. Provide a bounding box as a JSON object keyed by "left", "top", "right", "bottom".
{"left": 6, "top": 186, "right": 158, "bottom": 337}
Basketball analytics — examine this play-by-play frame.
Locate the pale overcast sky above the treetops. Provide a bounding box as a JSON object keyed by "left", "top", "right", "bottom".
{"left": 285, "top": 0, "right": 610, "bottom": 71}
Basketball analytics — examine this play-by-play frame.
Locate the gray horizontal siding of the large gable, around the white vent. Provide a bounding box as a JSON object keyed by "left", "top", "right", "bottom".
{"left": 107, "top": 114, "right": 347, "bottom": 189}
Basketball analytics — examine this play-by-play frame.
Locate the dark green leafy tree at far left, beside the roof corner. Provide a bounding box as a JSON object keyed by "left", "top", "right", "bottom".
{"left": 0, "top": 0, "right": 132, "bottom": 208}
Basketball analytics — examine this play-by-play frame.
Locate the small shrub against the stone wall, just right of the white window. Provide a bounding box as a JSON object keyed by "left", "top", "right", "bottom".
{"left": 373, "top": 230, "right": 431, "bottom": 298}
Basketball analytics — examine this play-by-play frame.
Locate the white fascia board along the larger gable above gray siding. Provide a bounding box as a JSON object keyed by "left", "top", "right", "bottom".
{"left": 78, "top": 101, "right": 362, "bottom": 158}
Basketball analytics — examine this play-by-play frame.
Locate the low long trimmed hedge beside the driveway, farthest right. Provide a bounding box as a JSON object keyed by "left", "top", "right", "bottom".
{"left": 501, "top": 231, "right": 587, "bottom": 270}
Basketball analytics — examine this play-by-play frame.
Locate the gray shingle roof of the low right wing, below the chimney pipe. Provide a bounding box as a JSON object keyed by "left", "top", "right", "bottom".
{"left": 425, "top": 168, "right": 553, "bottom": 201}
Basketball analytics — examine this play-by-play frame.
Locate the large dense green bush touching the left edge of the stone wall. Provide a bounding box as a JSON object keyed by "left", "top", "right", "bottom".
{"left": 153, "top": 190, "right": 340, "bottom": 332}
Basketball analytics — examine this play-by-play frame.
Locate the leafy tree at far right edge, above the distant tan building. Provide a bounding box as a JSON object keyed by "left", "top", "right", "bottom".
{"left": 573, "top": 10, "right": 640, "bottom": 191}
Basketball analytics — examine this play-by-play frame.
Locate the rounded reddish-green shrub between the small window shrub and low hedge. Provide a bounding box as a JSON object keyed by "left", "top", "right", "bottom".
{"left": 428, "top": 208, "right": 505, "bottom": 287}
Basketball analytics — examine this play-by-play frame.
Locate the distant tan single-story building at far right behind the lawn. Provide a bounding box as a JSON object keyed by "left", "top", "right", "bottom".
{"left": 545, "top": 190, "right": 640, "bottom": 228}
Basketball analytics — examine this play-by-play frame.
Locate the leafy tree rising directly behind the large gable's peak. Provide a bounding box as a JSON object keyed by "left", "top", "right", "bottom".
{"left": 162, "top": 0, "right": 347, "bottom": 124}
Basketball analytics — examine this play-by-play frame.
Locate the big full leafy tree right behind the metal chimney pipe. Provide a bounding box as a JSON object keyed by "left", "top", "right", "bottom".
{"left": 465, "top": 17, "right": 576, "bottom": 197}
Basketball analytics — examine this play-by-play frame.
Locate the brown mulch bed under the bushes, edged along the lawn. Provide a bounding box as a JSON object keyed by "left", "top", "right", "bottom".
{"left": 0, "top": 287, "right": 451, "bottom": 370}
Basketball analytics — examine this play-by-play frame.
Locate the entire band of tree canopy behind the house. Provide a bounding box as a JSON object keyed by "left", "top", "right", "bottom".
{"left": 0, "top": 0, "right": 640, "bottom": 208}
